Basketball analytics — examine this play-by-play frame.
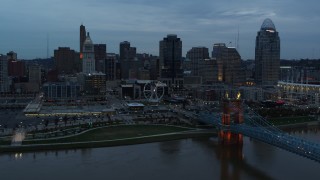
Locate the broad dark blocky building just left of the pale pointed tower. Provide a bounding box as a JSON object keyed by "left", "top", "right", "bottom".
{"left": 54, "top": 47, "right": 80, "bottom": 74}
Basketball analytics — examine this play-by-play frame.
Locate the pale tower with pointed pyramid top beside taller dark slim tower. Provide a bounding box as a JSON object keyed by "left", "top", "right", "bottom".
{"left": 82, "top": 33, "right": 96, "bottom": 74}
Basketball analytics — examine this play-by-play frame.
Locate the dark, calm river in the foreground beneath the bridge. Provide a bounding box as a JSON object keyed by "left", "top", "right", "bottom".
{"left": 0, "top": 128, "right": 320, "bottom": 180}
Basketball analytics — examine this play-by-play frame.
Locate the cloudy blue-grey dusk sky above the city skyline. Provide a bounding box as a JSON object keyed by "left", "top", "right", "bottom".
{"left": 0, "top": 0, "right": 320, "bottom": 59}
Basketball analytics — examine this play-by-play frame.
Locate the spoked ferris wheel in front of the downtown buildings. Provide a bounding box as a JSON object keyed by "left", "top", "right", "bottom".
{"left": 143, "top": 81, "right": 166, "bottom": 102}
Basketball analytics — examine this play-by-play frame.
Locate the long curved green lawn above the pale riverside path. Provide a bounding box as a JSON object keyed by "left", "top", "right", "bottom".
{"left": 23, "top": 125, "right": 192, "bottom": 144}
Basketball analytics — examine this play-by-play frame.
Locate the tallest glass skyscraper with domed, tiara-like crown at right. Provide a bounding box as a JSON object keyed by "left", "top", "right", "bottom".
{"left": 255, "top": 19, "right": 280, "bottom": 85}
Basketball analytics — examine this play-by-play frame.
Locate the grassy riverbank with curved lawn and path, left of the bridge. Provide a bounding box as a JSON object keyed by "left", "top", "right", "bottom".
{"left": 0, "top": 125, "right": 217, "bottom": 153}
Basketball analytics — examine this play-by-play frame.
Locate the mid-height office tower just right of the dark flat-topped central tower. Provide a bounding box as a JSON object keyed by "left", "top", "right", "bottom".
{"left": 187, "top": 47, "right": 209, "bottom": 76}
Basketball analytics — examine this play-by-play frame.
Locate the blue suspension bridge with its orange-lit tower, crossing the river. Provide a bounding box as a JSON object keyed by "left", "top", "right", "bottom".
{"left": 198, "top": 100, "right": 320, "bottom": 163}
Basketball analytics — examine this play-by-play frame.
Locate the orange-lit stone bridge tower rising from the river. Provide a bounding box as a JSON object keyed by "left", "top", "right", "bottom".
{"left": 219, "top": 94, "right": 243, "bottom": 145}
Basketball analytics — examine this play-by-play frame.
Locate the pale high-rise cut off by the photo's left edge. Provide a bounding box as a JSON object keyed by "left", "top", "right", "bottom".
{"left": 0, "top": 54, "right": 9, "bottom": 92}
